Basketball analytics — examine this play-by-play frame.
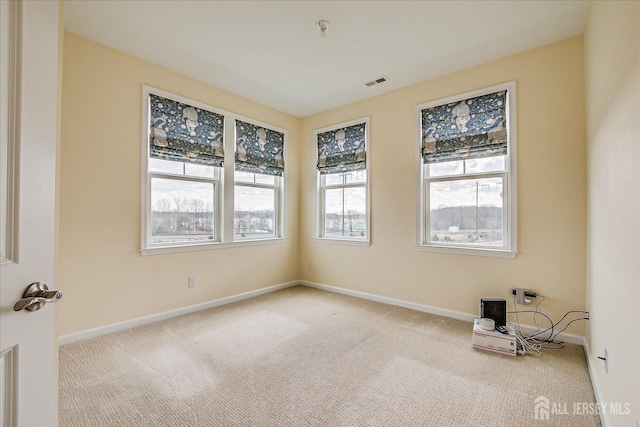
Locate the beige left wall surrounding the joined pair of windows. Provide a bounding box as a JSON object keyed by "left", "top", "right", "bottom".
{"left": 56, "top": 33, "right": 300, "bottom": 335}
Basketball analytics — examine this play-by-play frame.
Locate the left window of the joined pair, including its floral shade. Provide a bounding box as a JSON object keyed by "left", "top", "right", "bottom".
{"left": 145, "top": 93, "right": 224, "bottom": 247}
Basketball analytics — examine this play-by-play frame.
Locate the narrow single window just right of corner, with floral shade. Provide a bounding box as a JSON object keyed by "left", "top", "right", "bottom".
{"left": 315, "top": 118, "right": 369, "bottom": 244}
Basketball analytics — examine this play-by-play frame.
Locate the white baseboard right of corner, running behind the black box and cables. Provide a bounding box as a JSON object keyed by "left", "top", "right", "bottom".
{"left": 299, "top": 280, "right": 584, "bottom": 345}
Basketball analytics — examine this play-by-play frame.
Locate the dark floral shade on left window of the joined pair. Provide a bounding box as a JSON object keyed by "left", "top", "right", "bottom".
{"left": 149, "top": 94, "right": 224, "bottom": 166}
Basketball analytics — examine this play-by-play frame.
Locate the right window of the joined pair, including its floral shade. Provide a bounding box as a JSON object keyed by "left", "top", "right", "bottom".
{"left": 233, "top": 120, "right": 284, "bottom": 240}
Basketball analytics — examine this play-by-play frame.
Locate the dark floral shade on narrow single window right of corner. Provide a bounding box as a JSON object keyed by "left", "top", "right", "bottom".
{"left": 317, "top": 123, "right": 367, "bottom": 175}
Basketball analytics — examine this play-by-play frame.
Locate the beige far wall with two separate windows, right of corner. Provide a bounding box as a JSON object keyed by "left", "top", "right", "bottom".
{"left": 299, "top": 37, "right": 586, "bottom": 335}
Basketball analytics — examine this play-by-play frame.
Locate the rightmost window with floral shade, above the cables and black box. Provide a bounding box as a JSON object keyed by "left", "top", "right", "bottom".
{"left": 417, "top": 83, "right": 517, "bottom": 257}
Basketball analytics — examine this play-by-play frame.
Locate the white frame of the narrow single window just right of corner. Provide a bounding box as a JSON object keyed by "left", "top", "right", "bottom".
{"left": 313, "top": 116, "right": 371, "bottom": 246}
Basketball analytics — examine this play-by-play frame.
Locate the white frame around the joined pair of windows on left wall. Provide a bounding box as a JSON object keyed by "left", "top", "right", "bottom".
{"left": 140, "top": 85, "right": 287, "bottom": 255}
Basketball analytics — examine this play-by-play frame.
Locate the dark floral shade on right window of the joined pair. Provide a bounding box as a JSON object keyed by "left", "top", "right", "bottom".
{"left": 236, "top": 120, "right": 284, "bottom": 176}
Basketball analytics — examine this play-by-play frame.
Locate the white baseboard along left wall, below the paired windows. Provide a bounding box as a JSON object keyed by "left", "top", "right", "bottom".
{"left": 58, "top": 280, "right": 300, "bottom": 345}
